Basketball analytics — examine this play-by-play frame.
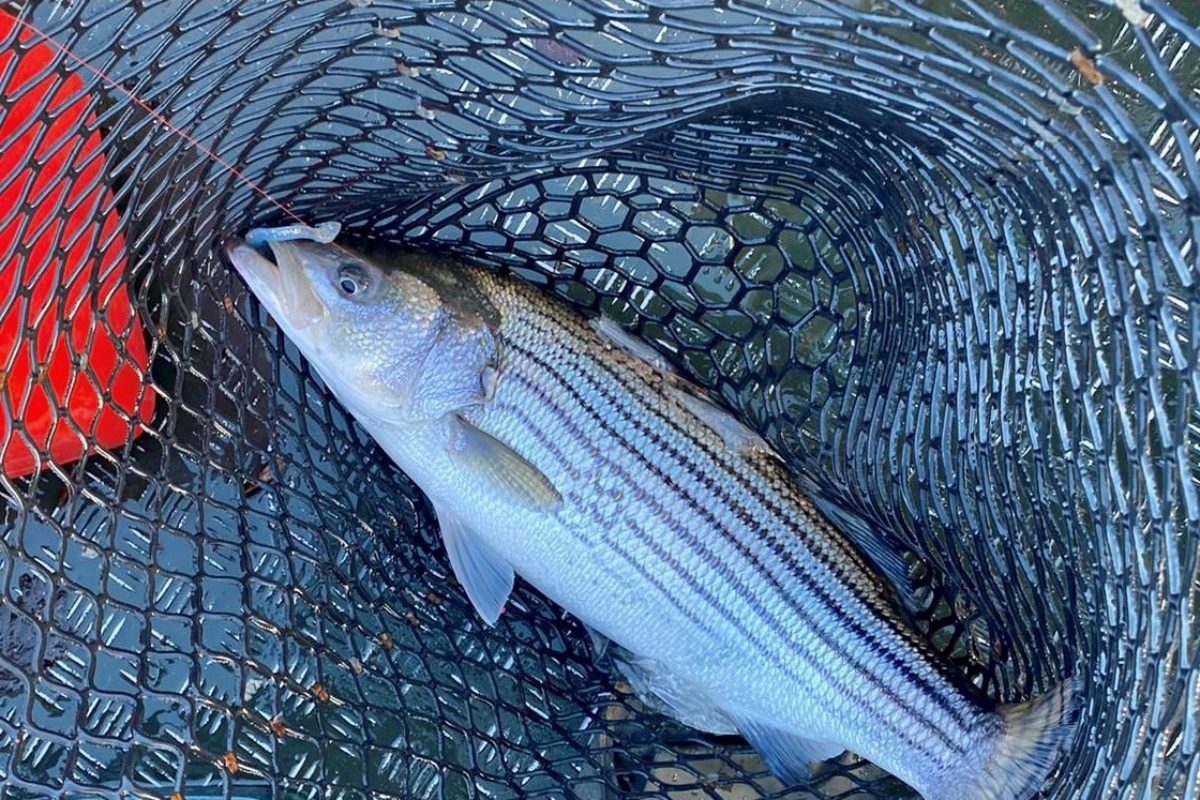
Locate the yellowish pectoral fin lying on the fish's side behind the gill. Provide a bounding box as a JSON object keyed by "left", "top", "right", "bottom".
{"left": 451, "top": 416, "right": 563, "bottom": 511}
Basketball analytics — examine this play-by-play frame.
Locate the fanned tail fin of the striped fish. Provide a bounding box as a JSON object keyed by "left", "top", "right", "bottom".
{"left": 962, "top": 680, "right": 1081, "bottom": 800}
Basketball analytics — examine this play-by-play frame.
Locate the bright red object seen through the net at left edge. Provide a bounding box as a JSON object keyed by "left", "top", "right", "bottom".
{"left": 0, "top": 12, "right": 154, "bottom": 476}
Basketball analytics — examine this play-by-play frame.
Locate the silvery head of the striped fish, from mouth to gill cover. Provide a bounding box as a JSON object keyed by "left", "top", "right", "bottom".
{"left": 227, "top": 232, "right": 494, "bottom": 422}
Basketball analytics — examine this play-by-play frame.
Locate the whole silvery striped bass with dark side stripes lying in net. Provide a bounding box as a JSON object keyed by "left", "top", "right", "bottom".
{"left": 228, "top": 220, "right": 1078, "bottom": 800}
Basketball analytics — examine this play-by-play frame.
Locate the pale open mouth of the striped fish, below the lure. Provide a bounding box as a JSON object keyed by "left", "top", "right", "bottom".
{"left": 226, "top": 239, "right": 329, "bottom": 331}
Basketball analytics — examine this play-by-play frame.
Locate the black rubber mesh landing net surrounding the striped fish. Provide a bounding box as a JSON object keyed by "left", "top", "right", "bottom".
{"left": 0, "top": 0, "right": 1200, "bottom": 800}
